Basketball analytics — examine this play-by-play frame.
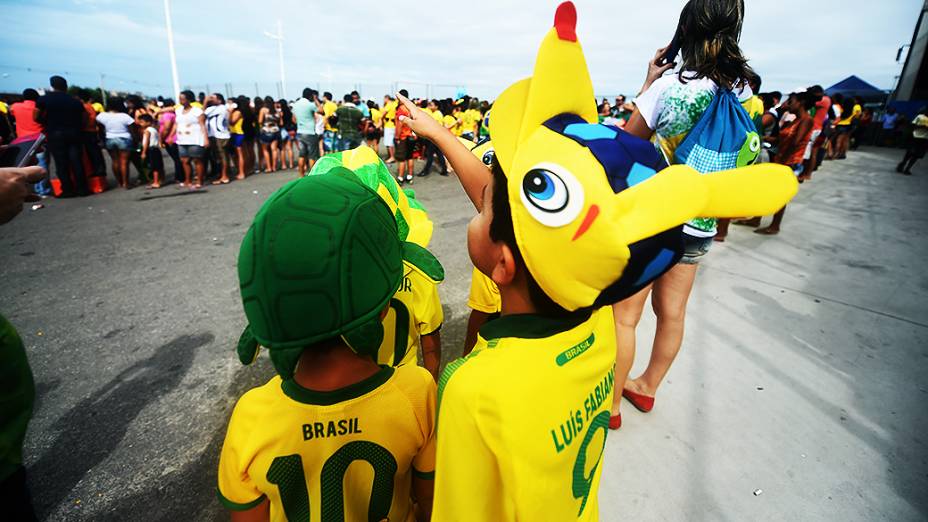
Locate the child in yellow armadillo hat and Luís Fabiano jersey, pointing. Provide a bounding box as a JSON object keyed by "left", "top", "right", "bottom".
{"left": 401, "top": 2, "right": 797, "bottom": 522}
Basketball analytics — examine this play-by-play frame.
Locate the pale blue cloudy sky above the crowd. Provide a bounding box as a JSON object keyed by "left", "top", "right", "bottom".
{"left": 0, "top": 0, "right": 923, "bottom": 98}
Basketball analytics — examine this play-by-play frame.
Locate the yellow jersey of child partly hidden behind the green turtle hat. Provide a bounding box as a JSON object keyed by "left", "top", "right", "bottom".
{"left": 377, "top": 268, "right": 444, "bottom": 366}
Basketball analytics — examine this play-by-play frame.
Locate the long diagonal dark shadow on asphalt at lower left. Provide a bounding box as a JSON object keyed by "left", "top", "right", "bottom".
{"left": 27, "top": 333, "right": 213, "bottom": 519}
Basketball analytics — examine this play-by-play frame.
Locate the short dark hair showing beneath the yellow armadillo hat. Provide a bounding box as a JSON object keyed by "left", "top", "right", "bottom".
{"left": 484, "top": 158, "right": 570, "bottom": 316}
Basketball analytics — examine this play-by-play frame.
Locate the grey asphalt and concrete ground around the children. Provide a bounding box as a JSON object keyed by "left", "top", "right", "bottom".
{"left": 0, "top": 144, "right": 928, "bottom": 521}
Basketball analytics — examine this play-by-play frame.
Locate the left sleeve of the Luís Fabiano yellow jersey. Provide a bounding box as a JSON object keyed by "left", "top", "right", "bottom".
{"left": 432, "top": 359, "right": 511, "bottom": 521}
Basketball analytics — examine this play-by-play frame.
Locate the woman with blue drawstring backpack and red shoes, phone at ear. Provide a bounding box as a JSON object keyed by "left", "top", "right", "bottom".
{"left": 610, "top": 0, "right": 760, "bottom": 429}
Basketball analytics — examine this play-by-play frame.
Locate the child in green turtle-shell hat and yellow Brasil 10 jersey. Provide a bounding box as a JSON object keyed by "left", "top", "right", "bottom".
{"left": 227, "top": 173, "right": 436, "bottom": 522}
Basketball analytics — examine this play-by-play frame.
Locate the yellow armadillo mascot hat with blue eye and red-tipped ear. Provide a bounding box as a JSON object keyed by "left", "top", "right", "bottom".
{"left": 490, "top": 2, "right": 798, "bottom": 311}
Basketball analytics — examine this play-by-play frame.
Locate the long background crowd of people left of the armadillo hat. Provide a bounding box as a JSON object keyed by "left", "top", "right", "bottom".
{"left": 0, "top": 80, "right": 490, "bottom": 194}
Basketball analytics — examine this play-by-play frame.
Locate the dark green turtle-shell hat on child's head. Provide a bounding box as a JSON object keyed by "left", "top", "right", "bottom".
{"left": 238, "top": 171, "right": 404, "bottom": 379}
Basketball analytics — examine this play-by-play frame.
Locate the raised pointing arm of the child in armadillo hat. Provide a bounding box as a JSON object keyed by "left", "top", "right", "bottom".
{"left": 397, "top": 94, "right": 490, "bottom": 211}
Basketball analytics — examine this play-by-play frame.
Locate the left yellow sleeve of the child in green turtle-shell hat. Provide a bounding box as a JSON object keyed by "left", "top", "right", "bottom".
{"left": 218, "top": 394, "right": 264, "bottom": 511}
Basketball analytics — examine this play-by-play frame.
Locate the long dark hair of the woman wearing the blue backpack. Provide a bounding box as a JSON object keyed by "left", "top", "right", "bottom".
{"left": 677, "top": 0, "right": 754, "bottom": 89}
